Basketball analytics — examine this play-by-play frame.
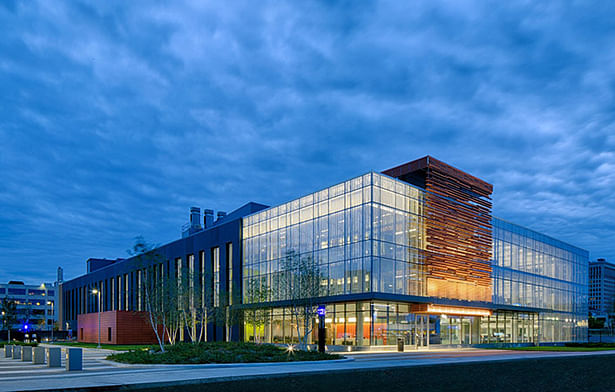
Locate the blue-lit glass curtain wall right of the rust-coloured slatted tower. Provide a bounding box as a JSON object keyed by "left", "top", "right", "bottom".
{"left": 492, "top": 219, "right": 589, "bottom": 342}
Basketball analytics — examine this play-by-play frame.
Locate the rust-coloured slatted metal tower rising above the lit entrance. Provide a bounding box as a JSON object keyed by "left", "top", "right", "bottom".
{"left": 383, "top": 156, "right": 493, "bottom": 302}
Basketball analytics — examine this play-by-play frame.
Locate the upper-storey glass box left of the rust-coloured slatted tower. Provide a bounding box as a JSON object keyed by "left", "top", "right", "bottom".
{"left": 243, "top": 173, "right": 425, "bottom": 303}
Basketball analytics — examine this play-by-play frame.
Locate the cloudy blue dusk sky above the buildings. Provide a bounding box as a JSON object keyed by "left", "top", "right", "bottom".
{"left": 0, "top": 0, "right": 615, "bottom": 284}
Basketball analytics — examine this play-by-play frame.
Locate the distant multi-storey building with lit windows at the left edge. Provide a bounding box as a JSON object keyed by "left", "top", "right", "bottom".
{"left": 0, "top": 281, "right": 59, "bottom": 332}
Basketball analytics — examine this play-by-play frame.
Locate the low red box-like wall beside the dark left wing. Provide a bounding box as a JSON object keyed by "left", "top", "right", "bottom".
{"left": 77, "top": 310, "right": 167, "bottom": 344}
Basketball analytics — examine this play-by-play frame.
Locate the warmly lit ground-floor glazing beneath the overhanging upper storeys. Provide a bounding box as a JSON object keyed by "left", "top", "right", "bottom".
{"left": 249, "top": 302, "right": 539, "bottom": 347}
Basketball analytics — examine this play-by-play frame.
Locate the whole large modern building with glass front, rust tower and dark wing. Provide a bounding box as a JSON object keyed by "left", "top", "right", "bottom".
{"left": 62, "top": 156, "right": 588, "bottom": 347}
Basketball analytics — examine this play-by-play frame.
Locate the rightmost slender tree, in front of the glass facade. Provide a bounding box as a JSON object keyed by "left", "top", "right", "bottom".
{"left": 280, "top": 251, "right": 323, "bottom": 349}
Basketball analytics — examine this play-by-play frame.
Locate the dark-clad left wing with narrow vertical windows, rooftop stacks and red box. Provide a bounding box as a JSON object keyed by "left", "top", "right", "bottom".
{"left": 61, "top": 203, "right": 267, "bottom": 344}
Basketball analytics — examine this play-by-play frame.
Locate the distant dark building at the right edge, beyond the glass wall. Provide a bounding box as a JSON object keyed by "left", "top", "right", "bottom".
{"left": 589, "top": 259, "right": 615, "bottom": 320}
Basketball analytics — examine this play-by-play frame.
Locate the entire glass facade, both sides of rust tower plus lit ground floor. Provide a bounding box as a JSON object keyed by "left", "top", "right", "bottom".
{"left": 242, "top": 172, "right": 588, "bottom": 346}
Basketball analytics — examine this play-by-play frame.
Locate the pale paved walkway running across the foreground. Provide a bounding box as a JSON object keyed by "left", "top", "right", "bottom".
{"left": 0, "top": 349, "right": 615, "bottom": 391}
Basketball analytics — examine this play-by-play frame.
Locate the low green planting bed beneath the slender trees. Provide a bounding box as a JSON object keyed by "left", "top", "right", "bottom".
{"left": 107, "top": 342, "right": 340, "bottom": 364}
